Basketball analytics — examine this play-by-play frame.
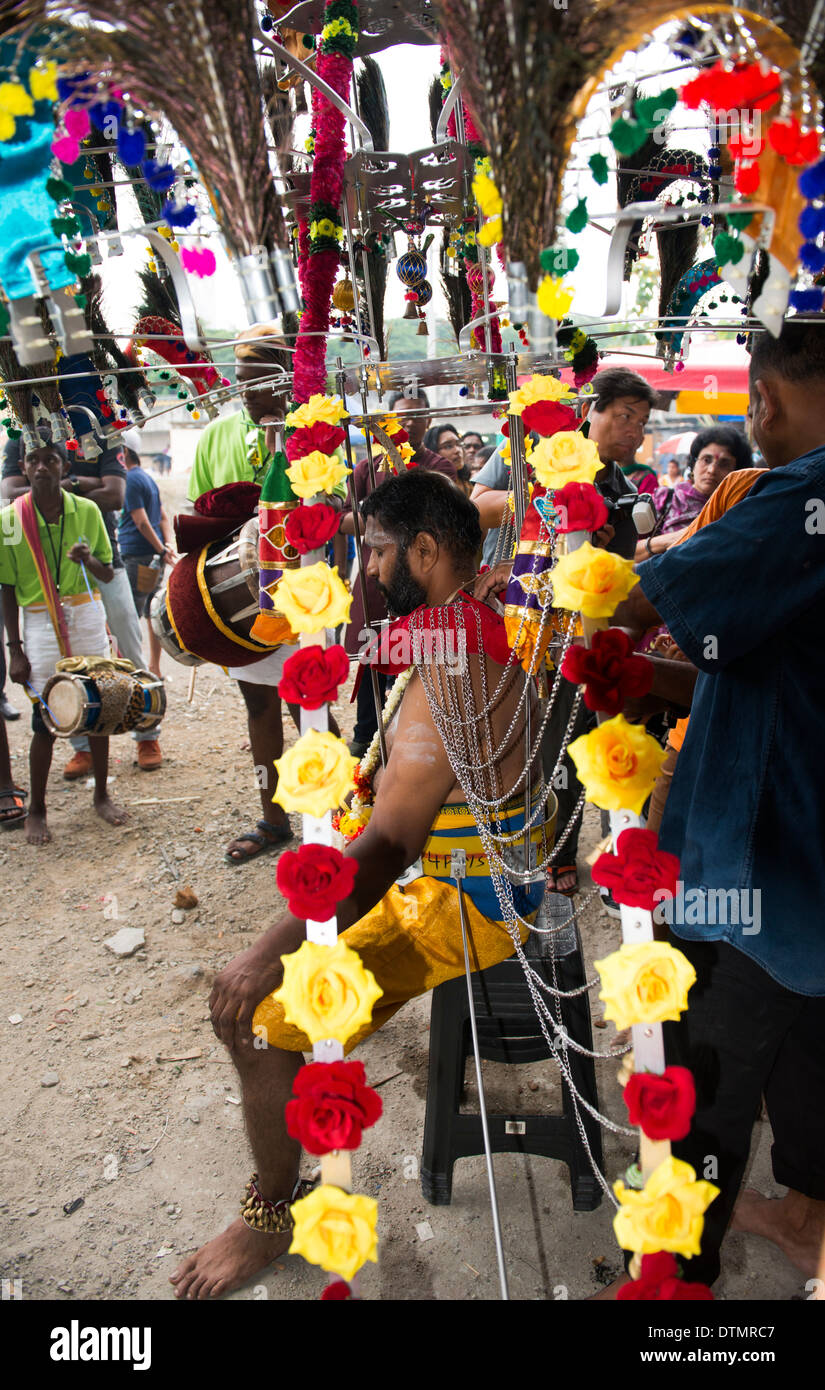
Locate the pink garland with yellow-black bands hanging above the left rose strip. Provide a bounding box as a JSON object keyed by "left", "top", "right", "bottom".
{"left": 293, "top": 0, "right": 358, "bottom": 402}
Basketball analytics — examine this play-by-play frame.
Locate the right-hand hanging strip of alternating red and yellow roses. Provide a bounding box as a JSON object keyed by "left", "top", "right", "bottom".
{"left": 515, "top": 494, "right": 718, "bottom": 1300}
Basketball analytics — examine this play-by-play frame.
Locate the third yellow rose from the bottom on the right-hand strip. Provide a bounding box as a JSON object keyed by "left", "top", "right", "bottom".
{"left": 566, "top": 717, "right": 667, "bottom": 816}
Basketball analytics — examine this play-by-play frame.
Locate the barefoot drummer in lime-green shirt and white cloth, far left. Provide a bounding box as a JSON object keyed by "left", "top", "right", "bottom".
{"left": 0, "top": 443, "right": 126, "bottom": 845}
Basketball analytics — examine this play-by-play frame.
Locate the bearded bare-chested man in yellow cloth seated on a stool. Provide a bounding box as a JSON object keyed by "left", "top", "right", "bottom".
{"left": 171, "top": 470, "right": 544, "bottom": 1298}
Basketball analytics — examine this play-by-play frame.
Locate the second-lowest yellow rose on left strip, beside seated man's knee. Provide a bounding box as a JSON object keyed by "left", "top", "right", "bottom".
{"left": 272, "top": 937, "right": 383, "bottom": 1043}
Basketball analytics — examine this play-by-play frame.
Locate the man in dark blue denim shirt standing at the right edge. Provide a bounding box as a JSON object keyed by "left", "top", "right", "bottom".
{"left": 614, "top": 321, "right": 825, "bottom": 1283}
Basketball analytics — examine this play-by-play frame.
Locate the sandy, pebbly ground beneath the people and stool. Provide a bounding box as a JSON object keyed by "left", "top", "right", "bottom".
{"left": 0, "top": 478, "right": 806, "bottom": 1300}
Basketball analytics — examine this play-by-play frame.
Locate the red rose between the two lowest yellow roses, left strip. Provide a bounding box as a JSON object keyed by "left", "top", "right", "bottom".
{"left": 285, "top": 1062, "right": 383, "bottom": 1154}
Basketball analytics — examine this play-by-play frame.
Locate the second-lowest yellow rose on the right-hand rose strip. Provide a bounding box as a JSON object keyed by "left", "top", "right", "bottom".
{"left": 594, "top": 941, "right": 696, "bottom": 1029}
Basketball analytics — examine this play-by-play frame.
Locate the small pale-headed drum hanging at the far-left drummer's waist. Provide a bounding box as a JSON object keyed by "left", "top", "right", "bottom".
{"left": 42, "top": 669, "right": 167, "bottom": 738}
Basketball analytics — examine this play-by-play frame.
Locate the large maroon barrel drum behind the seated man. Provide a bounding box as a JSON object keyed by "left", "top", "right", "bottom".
{"left": 159, "top": 517, "right": 286, "bottom": 666}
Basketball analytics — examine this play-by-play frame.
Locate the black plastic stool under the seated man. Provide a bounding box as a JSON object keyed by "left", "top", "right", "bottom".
{"left": 421, "top": 894, "right": 603, "bottom": 1212}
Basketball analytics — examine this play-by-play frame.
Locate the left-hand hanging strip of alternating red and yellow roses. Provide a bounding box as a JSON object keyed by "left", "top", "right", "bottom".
{"left": 253, "top": 389, "right": 382, "bottom": 1298}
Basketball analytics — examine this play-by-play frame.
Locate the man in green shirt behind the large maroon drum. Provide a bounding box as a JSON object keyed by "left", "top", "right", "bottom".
{"left": 189, "top": 322, "right": 336, "bottom": 863}
